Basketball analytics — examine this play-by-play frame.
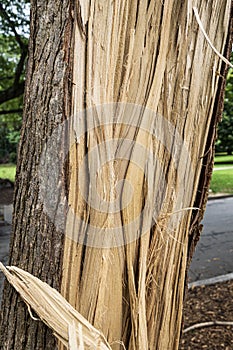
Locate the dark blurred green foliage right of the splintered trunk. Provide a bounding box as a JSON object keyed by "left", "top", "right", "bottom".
{"left": 216, "top": 54, "right": 233, "bottom": 154}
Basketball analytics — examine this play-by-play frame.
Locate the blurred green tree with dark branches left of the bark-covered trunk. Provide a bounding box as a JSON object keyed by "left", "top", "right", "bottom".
{"left": 0, "top": 0, "right": 30, "bottom": 163}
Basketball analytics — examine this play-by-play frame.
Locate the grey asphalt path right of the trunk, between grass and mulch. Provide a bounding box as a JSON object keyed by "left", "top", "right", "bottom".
{"left": 189, "top": 197, "right": 233, "bottom": 282}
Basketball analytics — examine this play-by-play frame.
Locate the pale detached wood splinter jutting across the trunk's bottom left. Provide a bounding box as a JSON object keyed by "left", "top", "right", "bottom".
{"left": 0, "top": 263, "right": 111, "bottom": 350}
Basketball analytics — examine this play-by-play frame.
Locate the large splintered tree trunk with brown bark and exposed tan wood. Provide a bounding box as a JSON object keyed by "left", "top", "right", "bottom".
{"left": 1, "top": 0, "right": 231, "bottom": 350}
